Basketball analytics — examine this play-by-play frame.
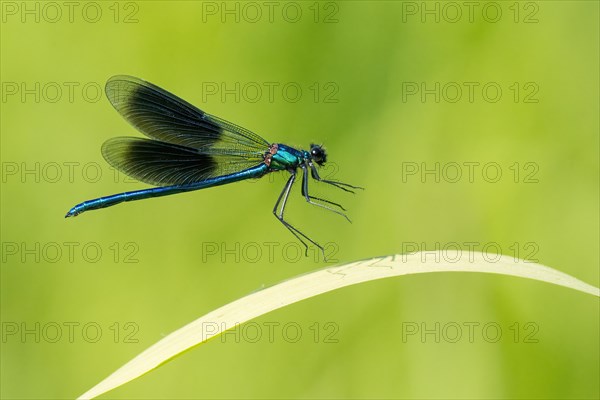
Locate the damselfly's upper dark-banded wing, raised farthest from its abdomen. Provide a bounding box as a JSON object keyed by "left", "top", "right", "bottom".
{"left": 105, "top": 75, "right": 270, "bottom": 158}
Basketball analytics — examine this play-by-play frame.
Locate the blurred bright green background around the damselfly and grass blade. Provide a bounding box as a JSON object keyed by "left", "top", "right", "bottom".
{"left": 0, "top": 1, "right": 600, "bottom": 399}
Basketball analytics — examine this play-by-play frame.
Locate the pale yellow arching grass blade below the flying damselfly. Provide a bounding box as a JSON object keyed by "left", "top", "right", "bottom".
{"left": 79, "top": 251, "right": 600, "bottom": 399}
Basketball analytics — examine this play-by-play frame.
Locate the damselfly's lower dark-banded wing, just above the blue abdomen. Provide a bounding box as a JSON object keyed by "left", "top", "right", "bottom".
{"left": 102, "top": 137, "right": 262, "bottom": 186}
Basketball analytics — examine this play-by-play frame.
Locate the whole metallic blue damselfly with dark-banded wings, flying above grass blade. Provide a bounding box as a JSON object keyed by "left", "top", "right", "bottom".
{"left": 65, "top": 76, "right": 362, "bottom": 254}
